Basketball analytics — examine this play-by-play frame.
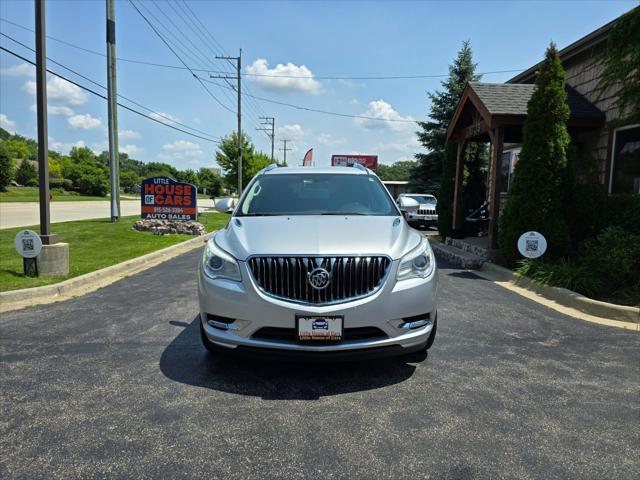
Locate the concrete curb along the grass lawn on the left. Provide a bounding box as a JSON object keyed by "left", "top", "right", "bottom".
{"left": 0, "top": 232, "right": 214, "bottom": 312}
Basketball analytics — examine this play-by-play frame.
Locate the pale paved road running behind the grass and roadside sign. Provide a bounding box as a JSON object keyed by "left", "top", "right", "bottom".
{"left": 0, "top": 200, "right": 218, "bottom": 228}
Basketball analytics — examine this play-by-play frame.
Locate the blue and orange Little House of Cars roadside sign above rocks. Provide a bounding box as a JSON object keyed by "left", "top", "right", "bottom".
{"left": 140, "top": 177, "right": 198, "bottom": 220}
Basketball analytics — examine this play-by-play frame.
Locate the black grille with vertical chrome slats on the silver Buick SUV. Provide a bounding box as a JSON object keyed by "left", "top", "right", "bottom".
{"left": 249, "top": 256, "right": 391, "bottom": 304}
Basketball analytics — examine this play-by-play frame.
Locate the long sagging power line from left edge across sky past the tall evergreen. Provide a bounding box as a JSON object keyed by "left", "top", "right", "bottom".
{"left": 0, "top": 16, "right": 525, "bottom": 80}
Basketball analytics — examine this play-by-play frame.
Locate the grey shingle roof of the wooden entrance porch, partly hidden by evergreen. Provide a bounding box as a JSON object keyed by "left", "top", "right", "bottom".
{"left": 469, "top": 82, "right": 604, "bottom": 118}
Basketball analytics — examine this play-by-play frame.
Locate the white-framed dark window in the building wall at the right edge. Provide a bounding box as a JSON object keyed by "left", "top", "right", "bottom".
{"left": 609, "top": 125, "right": 640, "bottom": 193}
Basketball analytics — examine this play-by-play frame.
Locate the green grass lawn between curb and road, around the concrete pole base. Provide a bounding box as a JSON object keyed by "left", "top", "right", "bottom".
{"left": 0, "top": 213, "right": 229, "bottom": 292}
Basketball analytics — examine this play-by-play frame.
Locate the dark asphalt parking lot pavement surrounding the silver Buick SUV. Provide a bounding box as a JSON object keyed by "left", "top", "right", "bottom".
{"left": 0, "top": 252, "right": 640, "bottom": 479}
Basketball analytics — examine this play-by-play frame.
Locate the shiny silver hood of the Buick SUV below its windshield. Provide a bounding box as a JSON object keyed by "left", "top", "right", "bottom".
{"left": 214, "top": 216, "right": 420, "bottom": 261}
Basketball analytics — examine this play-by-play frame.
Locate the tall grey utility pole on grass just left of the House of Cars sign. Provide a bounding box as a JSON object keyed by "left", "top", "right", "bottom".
{"left": 106, "top": 0, "right": 120, "bottom": 222}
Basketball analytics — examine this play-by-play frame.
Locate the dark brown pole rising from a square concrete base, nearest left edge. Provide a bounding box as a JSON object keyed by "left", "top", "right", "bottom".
{"left": 35, "top": 0, "right": 58, "bottom": 245}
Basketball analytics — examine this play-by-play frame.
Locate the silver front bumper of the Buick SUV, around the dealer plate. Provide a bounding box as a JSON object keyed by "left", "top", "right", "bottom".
{"left": 198, "top": 261, "right": 438, "bottom": 355}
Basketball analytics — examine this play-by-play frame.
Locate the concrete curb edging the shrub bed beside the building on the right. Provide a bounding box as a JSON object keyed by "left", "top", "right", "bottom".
{"left": 475, "top": 262, "right": 640, "bottom": 324}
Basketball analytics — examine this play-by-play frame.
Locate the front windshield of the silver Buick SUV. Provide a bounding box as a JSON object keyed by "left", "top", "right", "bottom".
{"left": 238, "top": 173, "right": 398, "bottom": 216}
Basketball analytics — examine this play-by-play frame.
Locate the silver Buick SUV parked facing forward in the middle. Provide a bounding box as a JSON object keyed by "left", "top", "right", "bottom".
{"left": 198, "top": 165, "right": 438, "bottom": 359}
